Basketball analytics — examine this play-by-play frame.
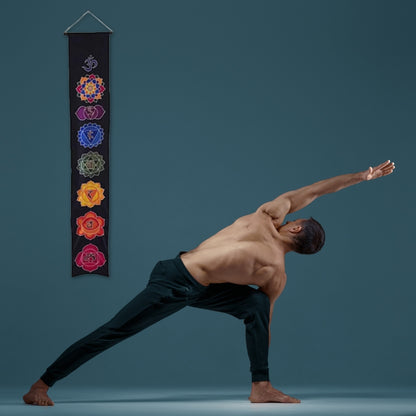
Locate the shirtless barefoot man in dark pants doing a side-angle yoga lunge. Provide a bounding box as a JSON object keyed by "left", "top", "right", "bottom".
{"left": 23, "top": 160, "right": 394, "bottom": 406}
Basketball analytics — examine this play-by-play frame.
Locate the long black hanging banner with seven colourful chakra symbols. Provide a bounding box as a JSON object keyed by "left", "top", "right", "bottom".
{"left": 66, "top": 32, "right": 111, "bottom": 276}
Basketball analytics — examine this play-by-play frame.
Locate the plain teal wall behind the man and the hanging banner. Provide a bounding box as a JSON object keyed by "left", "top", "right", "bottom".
{"left": 0, "top": 0, "right": 416, "bottom": 386}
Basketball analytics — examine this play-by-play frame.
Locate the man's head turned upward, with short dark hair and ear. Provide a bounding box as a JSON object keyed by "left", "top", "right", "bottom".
{"left": 278, "top": 217, "right": 325, "bottom": 254}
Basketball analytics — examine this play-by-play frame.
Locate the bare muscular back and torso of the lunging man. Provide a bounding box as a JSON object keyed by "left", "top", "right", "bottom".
{"left": 181, "top": 212, "right": 286, "bottom": 287}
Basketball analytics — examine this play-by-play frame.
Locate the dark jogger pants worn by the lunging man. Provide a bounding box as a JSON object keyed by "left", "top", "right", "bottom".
{"left": 41, "top": 256, "right": 270, "bottom": 386}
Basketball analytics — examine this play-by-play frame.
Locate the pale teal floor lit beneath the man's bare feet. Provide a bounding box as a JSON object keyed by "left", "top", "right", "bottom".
{"left": 0, "top": 386, "right": 416, "bottom": 416}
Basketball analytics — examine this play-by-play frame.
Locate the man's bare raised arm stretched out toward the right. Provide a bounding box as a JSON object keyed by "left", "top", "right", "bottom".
{"left": 257, "top": 160, "right": 395, "bottom": 225}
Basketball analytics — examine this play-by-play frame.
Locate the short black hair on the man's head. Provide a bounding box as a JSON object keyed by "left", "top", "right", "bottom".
{"left": 293, "top": 217, "right": 325, "bottom": 254}
